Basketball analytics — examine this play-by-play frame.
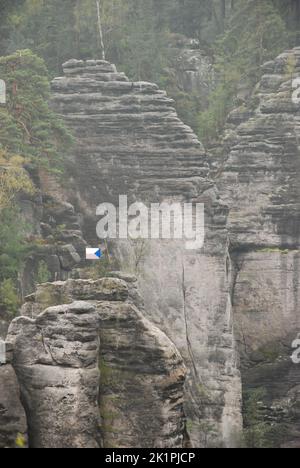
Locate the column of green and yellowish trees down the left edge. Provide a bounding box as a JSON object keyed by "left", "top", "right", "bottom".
{"left": 0, "top": 50, "right": 71, "bottom": 313}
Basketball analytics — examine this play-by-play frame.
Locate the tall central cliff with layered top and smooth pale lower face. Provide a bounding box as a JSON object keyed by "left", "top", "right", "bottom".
{"left": 52, "top": 60, "right": 242, "bottom": 446}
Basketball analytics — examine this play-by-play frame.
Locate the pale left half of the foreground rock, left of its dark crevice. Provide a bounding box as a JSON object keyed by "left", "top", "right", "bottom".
{"left": 8, "top": 302, "right": 101, "bottom": 448}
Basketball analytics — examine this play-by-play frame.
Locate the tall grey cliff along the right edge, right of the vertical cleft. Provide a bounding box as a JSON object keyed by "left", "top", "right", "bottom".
{"left": 219, "top": 48, "right": 300, "bottom": 446}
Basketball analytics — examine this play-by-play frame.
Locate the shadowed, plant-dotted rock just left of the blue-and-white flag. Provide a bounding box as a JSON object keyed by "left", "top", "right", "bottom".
{"left": 0, "top": 186, "right": 87, "bottom": 339}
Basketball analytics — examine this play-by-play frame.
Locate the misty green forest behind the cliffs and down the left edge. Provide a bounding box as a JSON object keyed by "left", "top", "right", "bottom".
{"left": 0, "top": 0, "right": 300, "bottom": 320}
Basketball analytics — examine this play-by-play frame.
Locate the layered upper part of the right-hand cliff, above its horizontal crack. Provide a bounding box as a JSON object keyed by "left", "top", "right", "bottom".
{"left": 219, "top": 49, "right": 300, "bottom": 248}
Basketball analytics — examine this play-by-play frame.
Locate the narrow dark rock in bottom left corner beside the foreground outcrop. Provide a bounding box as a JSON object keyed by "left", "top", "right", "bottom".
{"left": 0, "top": 345, "right": 27, "bottom": 448}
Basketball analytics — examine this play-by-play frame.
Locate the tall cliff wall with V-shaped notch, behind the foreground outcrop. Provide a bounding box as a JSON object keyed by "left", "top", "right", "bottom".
{"left": 47, "top": 49, "right": 300, "bottom": 446}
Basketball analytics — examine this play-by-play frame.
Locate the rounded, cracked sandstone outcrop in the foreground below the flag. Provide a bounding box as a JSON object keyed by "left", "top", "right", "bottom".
{"left": 7, "top": 278, "right": 186, "bottom": 448}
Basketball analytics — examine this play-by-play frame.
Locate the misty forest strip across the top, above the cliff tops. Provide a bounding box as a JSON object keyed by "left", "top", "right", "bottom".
{"left": 0, "top": 0, "right": 300, "bottom": 139}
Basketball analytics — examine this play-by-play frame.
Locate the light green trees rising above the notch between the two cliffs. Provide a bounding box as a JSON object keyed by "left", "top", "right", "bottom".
{"left": 198, "top": 0, "right": 288, "bottom": 143}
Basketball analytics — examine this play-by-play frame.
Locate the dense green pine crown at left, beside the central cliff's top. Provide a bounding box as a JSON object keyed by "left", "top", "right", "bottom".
{"left": 0, "top": 50, "right": 71, "bottom": 168}
